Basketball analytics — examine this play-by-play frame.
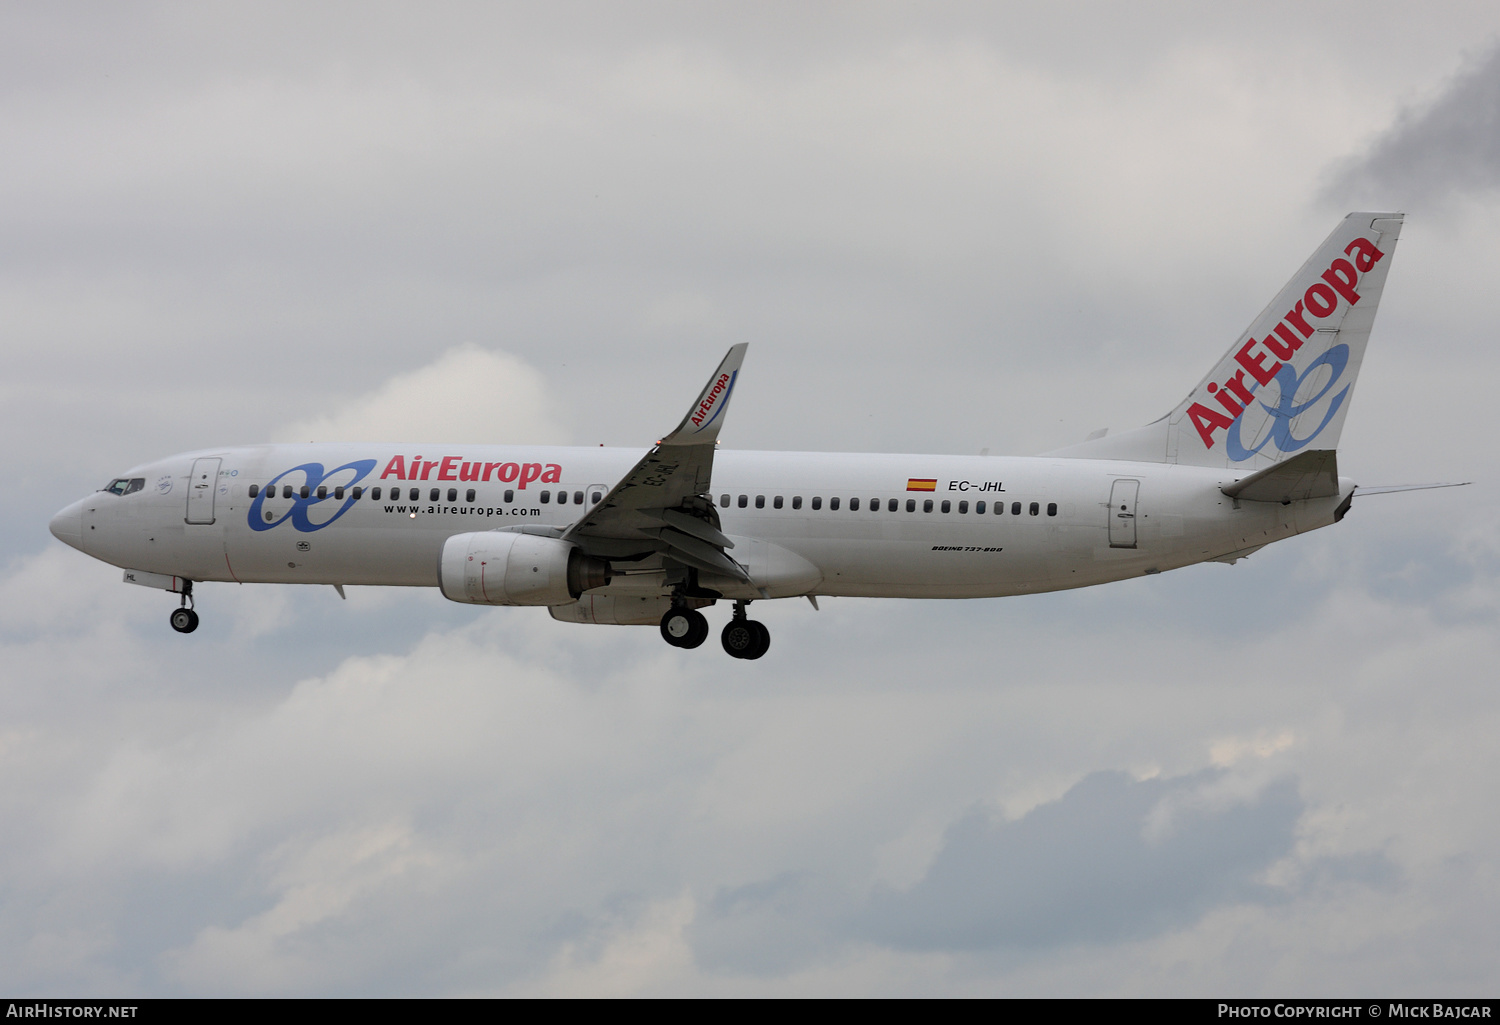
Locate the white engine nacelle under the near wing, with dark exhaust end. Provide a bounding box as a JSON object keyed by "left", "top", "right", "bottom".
{"left": 438, "top": 531, "right": 609, "bottom": 605}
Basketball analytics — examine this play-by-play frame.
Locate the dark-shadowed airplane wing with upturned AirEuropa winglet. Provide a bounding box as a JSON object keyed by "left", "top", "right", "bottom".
{"left": 563, "top": 342, "right": 747, "bottom": 579}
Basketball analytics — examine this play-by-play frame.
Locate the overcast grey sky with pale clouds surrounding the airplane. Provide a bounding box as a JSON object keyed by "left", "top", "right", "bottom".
{"left": 0, "top": 0, "right": 1500, "bottom": 995}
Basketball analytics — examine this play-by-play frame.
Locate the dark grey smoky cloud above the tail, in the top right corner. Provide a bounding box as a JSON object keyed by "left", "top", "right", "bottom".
{"left": 1323, "top": 45, "right": 1500, "bottom": 207}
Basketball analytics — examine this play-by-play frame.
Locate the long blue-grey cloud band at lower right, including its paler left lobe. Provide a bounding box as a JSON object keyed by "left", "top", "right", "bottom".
{"left": 690, "top": 770, "right": 1374, "bottom": 974}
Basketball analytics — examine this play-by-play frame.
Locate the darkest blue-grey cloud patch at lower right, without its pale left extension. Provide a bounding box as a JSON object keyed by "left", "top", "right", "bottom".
{"left": 863, "top": 770, "right": 1304, "bottom": 950}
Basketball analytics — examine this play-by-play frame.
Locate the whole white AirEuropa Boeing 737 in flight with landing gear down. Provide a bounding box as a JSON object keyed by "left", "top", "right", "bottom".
{"left": 51, "top": 213, "right": 1449, "bottom": 659}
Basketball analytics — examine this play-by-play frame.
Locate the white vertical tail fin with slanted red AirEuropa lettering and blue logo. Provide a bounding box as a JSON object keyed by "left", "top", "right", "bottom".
{"left": 1052, "top": 213, "right": 1403, "bottom": 471}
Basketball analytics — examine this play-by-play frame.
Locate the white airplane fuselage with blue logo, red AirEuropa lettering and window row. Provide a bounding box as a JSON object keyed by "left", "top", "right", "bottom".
{"left": 54, "top": 444, "right": 1353, "bottom": 597}
